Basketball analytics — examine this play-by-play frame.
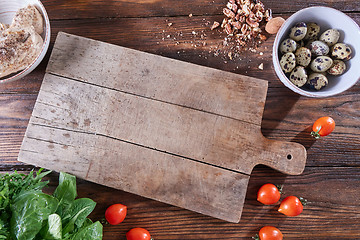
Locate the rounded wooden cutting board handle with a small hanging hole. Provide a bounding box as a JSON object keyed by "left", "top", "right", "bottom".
{"left": 259, "top": 137, "right": 306, "bottom": 175}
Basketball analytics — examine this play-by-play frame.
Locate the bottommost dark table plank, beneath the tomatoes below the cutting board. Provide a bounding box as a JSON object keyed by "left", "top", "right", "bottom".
{"left": 34, "top": 167, "right": 360, "bottom": 240}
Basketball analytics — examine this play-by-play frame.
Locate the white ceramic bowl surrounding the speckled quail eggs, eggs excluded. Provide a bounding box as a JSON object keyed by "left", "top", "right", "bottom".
{"left": 273, "top": 7, "right": 360, "bottom": 98}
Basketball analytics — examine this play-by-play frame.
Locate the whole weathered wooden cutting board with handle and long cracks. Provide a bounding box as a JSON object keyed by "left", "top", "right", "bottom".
{"left": 19, "top": 33, "right": 306, "bottom": 222}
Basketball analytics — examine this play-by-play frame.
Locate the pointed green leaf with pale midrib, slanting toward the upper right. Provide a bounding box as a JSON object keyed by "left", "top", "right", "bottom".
{"left": 63, "top": 198, "right": 96, "bottom": 235}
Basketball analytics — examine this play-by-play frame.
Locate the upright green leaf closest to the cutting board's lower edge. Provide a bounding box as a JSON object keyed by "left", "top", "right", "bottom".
{"left": 53, "top": 172, "right": 77, "bottom": 218}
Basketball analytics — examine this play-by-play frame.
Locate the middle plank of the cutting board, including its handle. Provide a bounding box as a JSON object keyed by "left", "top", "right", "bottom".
{"left": 24, "top": 72, "right": 306, "bottom": 174}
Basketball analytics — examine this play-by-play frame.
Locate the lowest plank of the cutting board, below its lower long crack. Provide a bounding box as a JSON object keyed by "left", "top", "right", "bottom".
{"left": 19, "top": 124, "right": 249, "bottom": 222}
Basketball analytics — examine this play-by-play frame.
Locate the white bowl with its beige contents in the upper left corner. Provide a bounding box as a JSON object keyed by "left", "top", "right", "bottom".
{"left": 0, "top": 0, "right": 50, "bottom": 83}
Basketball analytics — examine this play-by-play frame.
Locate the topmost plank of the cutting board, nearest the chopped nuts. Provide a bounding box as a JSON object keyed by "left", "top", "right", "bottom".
{"left": 46, "top": 32, "right": 268, "bottom": 126}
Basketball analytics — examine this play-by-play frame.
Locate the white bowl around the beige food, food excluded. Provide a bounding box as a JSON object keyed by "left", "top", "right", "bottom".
{"left": 0, "top": 0, "right": 50, "bottom": 83}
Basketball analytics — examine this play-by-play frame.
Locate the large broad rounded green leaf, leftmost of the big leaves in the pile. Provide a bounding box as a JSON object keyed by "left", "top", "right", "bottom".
{"left": 10, "top": 191, "right": 59, "bottom": 240}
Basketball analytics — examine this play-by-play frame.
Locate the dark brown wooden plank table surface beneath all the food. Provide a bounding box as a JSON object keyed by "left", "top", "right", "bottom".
{"left": 0, "top": 0, "right": 360, "bottom": 240}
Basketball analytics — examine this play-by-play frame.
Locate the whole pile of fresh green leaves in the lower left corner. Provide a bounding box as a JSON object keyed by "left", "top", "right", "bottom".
{"left": 0, "top": 169, "right": 102, "bottom": 240}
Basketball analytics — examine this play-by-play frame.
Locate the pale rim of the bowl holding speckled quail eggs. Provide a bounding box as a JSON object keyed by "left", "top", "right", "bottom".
{"left": 272, "top": 6, "right": 360, "bottom": 98}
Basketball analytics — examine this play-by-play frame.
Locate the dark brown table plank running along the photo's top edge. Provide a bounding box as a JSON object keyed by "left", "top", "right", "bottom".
{"left": 43, "top": 0, "right": 360, "bottom": 19}
